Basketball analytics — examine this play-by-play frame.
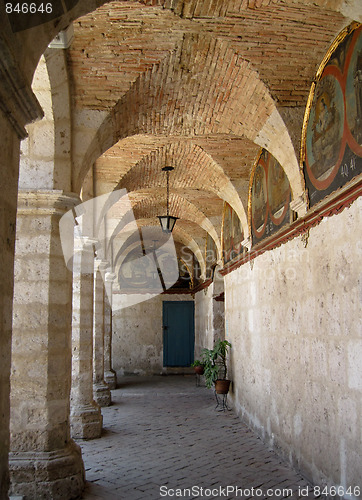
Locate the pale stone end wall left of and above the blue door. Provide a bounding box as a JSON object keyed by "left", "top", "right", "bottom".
{"left": 112, "top": 293, "right": 192, "bottom": 379}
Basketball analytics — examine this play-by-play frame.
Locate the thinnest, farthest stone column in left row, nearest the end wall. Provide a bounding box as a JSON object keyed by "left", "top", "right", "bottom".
{"left": 104, "top": 273, "right": 117, "bottom": 389}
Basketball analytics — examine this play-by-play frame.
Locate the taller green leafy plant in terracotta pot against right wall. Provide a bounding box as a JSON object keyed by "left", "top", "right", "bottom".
{"left": 202, "top": 340, "right": 231, "bottom": 394}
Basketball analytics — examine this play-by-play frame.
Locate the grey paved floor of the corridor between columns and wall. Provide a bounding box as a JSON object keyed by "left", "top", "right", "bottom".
{"left": 79, "top": 375, "right": 315, "bottom": 500}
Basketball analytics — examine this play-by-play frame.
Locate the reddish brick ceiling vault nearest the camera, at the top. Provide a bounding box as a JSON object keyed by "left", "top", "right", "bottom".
{"left": 69, "top": 0, "right": 345, "bottom": 109}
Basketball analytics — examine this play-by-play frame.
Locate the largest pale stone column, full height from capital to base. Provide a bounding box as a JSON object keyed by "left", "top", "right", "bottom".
{"left": 9, "top": 190, "right": 84, "bottom": 500}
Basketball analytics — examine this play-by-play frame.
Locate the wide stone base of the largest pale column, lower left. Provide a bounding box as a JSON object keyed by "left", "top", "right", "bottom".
{"left": 9, "top": 441, "right": 85, "bottom": 500}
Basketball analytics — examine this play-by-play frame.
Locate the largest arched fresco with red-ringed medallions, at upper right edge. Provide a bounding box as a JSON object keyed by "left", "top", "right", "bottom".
{"left": 302, "top": 25, "right": 362, "bottom": 206}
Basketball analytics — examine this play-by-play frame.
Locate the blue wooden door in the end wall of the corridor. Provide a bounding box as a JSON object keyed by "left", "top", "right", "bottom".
{"left": 163, "top": 301, "right": 195, "bottom": 366}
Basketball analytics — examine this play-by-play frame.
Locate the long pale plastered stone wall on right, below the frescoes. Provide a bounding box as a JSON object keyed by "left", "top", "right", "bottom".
{"left": 223, "top": 198, "right": 362, "bottom": 487}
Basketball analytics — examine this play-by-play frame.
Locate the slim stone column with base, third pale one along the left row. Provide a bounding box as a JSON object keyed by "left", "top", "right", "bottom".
{"left": 93, "top": 259, "right": 111, "bottom": 406}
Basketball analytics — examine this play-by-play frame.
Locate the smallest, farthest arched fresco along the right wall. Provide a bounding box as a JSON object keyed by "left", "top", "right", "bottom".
{"left": 222, "top": 203, "right": 244, "bottom": 264}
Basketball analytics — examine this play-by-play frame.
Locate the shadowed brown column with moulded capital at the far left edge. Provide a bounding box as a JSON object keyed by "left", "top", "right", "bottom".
{"left": 0, "top": 35, "right": 43, "bottom": 498}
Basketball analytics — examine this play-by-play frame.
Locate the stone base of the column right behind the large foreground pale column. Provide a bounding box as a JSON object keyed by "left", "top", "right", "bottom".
{"left": 70, "top": 402, "right": 103, "bottom": 439}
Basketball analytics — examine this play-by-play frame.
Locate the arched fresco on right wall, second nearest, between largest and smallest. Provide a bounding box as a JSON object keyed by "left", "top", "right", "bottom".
{"left": 249, "top": 149, "right": 291, "bottom": 244}
